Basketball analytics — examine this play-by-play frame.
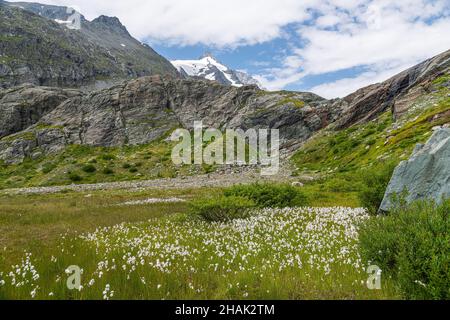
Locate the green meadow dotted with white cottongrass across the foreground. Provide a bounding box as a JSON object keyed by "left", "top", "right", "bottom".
{"left": 0, "top": 189, "right": 399, "bottom": 299}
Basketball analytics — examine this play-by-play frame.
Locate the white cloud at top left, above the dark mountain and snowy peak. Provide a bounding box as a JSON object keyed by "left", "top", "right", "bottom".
{"left": 9, "top": 0, "right": 317, "bottom": 47}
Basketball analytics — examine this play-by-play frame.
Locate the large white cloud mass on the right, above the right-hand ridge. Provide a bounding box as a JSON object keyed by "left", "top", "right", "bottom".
{"left": 258, "top": 0, "right": 450, "bottom": 98}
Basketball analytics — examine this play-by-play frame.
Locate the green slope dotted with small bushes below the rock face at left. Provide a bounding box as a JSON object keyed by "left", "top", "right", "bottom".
{"left": 0, "top": 137, "right": 192, "bottom": 189}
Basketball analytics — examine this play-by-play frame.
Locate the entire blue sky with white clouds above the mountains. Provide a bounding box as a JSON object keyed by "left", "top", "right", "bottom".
{"left": 10, "top": 0, "right": 450, "bottom": 98}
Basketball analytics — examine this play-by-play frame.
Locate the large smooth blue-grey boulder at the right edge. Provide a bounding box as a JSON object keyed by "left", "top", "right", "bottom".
{"left": 380, "top": 128, "right": 450, "bottom": 211}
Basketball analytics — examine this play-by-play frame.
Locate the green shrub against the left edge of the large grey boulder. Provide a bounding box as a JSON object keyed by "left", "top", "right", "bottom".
{"left": 358, "top": 162, "right": 396, "bottom": 214}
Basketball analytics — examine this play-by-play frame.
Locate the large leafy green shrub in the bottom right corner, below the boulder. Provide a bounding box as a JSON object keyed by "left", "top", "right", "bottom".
{"left": 360, "top": 199, "right": 450, "bottom": 300}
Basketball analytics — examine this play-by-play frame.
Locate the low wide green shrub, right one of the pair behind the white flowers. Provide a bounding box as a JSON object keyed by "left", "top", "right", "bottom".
{"left": 224, "top": 183, "right": 307, "bottom": 208}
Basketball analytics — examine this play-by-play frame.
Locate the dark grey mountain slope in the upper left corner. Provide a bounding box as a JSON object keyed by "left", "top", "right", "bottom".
{"left": 0, "top": 2, "right": 178, "bottom": 88}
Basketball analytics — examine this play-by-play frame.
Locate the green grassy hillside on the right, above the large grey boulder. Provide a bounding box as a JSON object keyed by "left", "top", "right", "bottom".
{"left": 292, "top": 88, "right": 450, "bottom": 177}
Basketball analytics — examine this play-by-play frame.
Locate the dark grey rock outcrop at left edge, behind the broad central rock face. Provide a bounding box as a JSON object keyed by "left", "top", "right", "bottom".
{"left": 0, "top": 84, "right": 81, "bottom": 138}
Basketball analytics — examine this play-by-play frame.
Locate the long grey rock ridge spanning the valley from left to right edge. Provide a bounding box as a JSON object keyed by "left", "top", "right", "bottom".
{"left": 0, "top": 51, "right": 450, "bottom": 168}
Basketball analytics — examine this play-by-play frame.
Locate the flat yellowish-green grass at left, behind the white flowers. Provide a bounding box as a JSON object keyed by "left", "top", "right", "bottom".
{"left": 0, "top": 189, "right": 205, "bottom": 256}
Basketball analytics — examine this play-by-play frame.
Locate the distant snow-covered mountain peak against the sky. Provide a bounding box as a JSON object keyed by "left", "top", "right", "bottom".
{"left": 172, "top": 54, "right": 263, "bottom": 89}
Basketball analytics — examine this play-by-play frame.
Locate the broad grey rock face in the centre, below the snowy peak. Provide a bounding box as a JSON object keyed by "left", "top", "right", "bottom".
{"left": 0, "top": 76, "right": 341, "bottom": 163}
